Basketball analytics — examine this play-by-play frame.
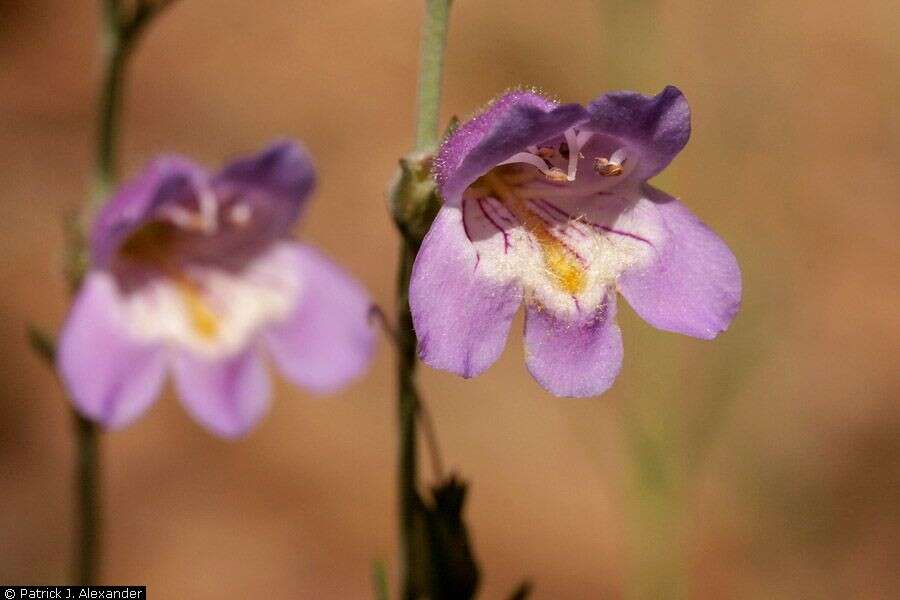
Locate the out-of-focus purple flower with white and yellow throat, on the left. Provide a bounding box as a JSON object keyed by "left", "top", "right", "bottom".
{"left": 59, "top": 142, "right": 374, "bottom": 437}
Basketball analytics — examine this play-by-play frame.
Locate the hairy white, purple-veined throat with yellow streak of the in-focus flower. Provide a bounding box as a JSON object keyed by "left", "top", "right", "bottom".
{"left": 462, "top": 129, "right": 663, "bottom": 317}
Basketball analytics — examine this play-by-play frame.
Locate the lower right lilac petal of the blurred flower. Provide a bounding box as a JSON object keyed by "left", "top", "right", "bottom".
{"left": 266, "top": 244, "right": 375, "bottom": 393}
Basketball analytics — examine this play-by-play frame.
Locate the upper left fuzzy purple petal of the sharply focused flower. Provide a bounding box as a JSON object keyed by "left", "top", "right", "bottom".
{"left": 434, "top": 90, "right": 589, "bottom": 205}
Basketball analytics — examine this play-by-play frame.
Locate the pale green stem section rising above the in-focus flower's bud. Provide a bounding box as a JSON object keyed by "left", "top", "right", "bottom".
{"left": 416, "top": 0, "right": 452, "bottom": 151}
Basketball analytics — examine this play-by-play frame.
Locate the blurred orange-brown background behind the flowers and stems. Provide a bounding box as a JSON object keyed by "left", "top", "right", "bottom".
{"left": 0, "top": 0, "right": 900, "bottom": 599}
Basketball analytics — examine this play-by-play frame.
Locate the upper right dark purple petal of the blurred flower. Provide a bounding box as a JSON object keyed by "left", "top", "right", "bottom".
{"left": 213, "top": 140, "right": 316, "bottom": 230}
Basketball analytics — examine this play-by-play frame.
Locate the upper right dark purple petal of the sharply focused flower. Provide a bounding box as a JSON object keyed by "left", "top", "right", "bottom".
{"left": 584, "top": 85, "right": 691, "bottom": 180}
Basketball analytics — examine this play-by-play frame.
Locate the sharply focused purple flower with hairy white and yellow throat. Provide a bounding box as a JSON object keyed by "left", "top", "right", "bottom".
{"left": 410, "top": 86, "right": 741, "bottom": 396}
